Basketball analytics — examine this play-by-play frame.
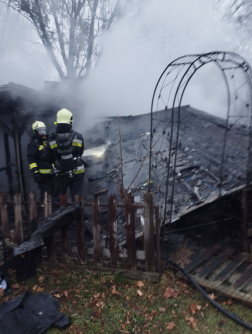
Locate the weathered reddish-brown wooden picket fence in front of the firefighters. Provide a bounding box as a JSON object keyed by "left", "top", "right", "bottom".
{"left": 0, "top": 193, "right": 161, "bottom": 273}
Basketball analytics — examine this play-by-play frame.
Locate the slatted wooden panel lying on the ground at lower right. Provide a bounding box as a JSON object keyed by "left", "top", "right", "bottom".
{"left": 183, "top": 245, "right": 252, "bottom": 307}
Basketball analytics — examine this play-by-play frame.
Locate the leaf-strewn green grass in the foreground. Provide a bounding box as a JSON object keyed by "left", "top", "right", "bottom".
{"left": 0, "top": 269, "right": 252, "bottom": 334}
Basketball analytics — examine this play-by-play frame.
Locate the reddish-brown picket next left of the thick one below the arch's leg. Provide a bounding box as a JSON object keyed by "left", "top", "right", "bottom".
{"left": 125, "top": 194, "right": 137, "bottom": 270}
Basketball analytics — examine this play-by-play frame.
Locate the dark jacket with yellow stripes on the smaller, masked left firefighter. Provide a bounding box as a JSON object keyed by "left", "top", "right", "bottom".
{"left": 27, "top": 135, "right": 52, "bottom": 175}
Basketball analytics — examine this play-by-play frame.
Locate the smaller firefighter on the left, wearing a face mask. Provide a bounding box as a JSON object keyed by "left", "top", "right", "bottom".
{"left": 27, "top": 121, "right": 59, "bottom": 202}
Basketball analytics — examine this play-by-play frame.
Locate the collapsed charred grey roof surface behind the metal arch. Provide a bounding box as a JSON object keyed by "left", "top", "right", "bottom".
{"left": 85, "top": 105, "right": 248, "bottom": 221}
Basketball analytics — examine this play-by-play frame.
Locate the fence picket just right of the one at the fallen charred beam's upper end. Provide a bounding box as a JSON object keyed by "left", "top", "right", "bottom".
{"left": 92, "top": 202, "right": 102, "bottom": 266}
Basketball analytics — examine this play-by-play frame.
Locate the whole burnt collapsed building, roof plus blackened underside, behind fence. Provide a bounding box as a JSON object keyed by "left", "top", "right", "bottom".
{"left": 84, "top": 105, "right": 248, "bottom": 248}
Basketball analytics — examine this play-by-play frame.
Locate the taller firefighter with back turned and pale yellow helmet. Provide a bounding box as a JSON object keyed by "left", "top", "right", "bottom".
{"left": 44, "top": 109, "right": 85, "bottom": 202}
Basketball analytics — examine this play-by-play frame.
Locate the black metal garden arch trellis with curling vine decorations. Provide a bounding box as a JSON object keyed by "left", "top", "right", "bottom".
{"left": 148, "top": 51, "right": 252, "bottom": 241}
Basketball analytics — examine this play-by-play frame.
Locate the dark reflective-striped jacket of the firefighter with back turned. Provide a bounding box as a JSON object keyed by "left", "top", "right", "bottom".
{"left": 44, "top": 124, "right": 85, "bottom": 175}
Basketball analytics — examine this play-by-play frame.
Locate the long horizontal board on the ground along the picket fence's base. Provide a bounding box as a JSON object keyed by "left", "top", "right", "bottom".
{"left": 43, "top": 262, "right": 159, "bottom": 283}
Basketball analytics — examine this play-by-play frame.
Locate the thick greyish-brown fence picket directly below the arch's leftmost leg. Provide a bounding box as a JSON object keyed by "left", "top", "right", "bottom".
{"left": 144, "top": 193, "right": 155, "bottom": 271}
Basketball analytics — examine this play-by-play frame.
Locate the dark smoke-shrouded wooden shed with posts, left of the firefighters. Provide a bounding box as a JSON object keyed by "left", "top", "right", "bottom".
{"left": 0, "top": 83, "right": 63, "bottom": 201}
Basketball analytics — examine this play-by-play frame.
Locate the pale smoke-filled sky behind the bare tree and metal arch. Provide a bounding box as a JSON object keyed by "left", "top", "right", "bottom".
{"left": 0, "top": 0, "right": 249, "bottom": 123}
